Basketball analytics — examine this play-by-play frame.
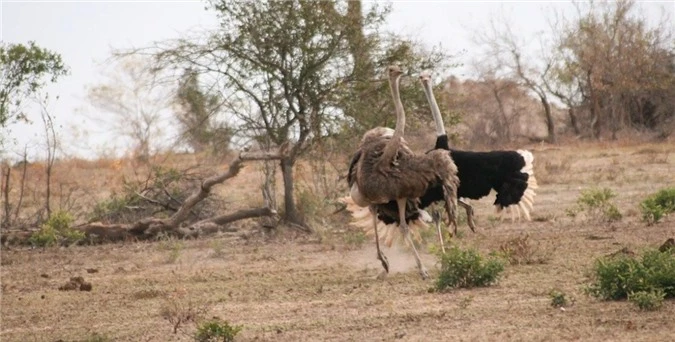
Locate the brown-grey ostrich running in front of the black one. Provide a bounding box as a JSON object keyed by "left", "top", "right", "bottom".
{"left": 351, "top": 66, "right": 459, "bottom": 279}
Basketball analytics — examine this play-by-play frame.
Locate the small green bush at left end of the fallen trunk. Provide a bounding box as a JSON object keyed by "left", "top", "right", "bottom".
{"left": 28, "top": 211, "right": 85, "bottom": 247}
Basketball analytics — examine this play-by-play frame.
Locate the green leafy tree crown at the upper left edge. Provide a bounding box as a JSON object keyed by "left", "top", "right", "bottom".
{"left": 0, "top": 41, "right": 68, "bottom": 127}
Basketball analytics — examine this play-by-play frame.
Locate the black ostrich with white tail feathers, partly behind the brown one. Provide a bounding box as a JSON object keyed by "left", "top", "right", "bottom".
{"left": 419, "top": 70, "right": 537, "bottom": 231}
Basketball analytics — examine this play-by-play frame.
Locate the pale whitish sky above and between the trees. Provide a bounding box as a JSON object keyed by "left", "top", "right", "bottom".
{"left": 0, "top": 0, "right": 675, "bottom": 159}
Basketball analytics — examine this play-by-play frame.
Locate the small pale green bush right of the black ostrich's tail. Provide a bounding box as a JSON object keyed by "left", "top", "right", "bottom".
{"left": 567, "top": 188, "right": 622, "bottom": 222}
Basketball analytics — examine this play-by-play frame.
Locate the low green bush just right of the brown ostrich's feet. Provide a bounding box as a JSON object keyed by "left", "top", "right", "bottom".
{"left": 436, "top": 246, "right": 504, "bottom": 291}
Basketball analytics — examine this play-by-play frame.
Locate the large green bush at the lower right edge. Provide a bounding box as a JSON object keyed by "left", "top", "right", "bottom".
{"left": 587, "top": 250, "right": 675, "bottom": 300}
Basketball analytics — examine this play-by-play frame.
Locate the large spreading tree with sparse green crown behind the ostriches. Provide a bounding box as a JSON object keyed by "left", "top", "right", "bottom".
{"left": 139, "top": 0, "right": 454, "bottom": 226}
